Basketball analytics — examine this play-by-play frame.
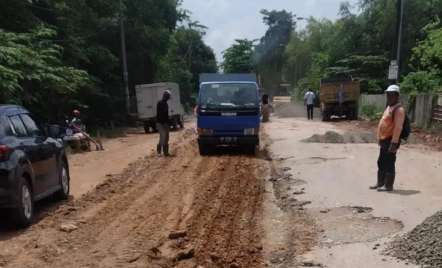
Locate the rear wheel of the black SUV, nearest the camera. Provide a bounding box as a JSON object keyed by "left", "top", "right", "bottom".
{"left": 12, "top": 177, "right": 34, "bottom": 228}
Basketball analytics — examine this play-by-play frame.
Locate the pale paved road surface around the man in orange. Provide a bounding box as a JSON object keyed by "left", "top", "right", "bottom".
{"left": 265, "top": 118, "right": 442, "bottom": 268}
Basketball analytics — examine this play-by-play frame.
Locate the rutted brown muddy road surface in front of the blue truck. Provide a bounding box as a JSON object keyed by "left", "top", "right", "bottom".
{"left": 0, "top": 129, "right": 282, "bottom": 268}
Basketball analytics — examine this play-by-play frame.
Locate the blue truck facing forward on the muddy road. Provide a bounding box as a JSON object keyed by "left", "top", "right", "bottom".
{"left": 197, "top": 73, "right": 266, "bottom": 155}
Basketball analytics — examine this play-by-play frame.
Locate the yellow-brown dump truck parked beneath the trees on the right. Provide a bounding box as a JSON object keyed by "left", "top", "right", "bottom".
{"left": 319, "top": 78, "right": 361, "bottom": 121}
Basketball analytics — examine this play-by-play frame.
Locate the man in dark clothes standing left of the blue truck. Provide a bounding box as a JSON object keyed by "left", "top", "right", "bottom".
{"left": 157, "top": 90, "right": 172, "bottom": 156}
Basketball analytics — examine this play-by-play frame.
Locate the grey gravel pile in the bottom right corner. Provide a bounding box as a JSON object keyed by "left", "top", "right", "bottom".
{"left": 385, "top": 210, "right": 442, "bottom": 268}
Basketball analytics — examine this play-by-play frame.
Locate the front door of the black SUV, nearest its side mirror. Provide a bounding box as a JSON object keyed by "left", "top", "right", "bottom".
{"left": 20, "top": 113, "right": 59, "bottom": 191}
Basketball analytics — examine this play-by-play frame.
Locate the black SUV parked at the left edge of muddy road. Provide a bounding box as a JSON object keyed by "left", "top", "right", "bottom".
{"left": 0, "top": 105, "right": 70, "bottom": 227}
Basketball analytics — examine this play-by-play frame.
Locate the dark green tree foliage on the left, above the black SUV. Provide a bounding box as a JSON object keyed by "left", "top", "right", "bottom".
{"left": 0, "top": 0, "right": 216, "bottom": 123}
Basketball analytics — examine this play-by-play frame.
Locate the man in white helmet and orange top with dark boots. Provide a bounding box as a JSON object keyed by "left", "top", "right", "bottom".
{"left": 370, "top": 85, "right": 405, "bottom": 192}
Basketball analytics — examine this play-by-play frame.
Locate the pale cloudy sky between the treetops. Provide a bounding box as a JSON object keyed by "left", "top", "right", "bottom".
{"left": 183, "top": 0, "right": 358, "bottom": 62}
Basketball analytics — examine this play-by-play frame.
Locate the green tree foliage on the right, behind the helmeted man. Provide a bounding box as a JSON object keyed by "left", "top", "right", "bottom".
{"left": 284, "top": 0, "right": 442, "bottom": 98}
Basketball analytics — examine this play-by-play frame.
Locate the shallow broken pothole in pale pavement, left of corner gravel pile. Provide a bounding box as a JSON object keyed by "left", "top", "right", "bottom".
{"left": 310, "top": 207, "right": 403, "bottom": 246}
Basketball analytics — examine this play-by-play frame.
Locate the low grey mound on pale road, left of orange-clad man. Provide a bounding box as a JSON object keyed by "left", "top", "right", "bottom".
{"left": 302, "top": 131, "right": 377, "bottom": 143}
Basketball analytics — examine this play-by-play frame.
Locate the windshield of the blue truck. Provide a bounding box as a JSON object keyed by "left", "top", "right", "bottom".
{"left": 200, "top": 83, "right": 258, "bottom": 108}
